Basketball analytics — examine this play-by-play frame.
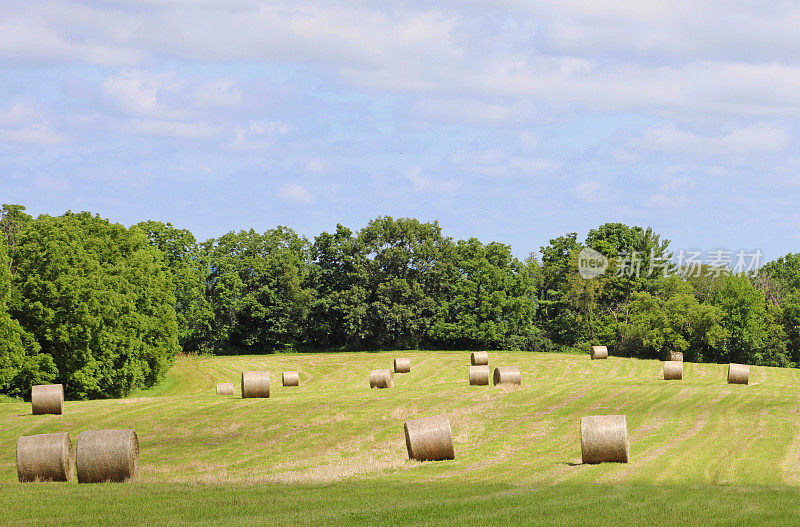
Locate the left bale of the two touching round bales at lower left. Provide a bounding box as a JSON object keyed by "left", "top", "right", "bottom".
{"left": 17, "top": 432, "right": 74, "bottom": 483}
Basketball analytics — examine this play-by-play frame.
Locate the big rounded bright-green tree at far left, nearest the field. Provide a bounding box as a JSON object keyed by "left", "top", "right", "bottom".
{"left": 10, "top": 212, "right": 179, "bottom": 398}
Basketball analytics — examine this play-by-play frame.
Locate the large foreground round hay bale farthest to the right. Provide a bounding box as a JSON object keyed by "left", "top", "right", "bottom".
{"left": 581, "top": 415, "right": 629, "bottom": 463}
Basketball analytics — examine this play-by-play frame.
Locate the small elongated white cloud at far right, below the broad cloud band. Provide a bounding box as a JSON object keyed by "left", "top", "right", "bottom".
{"left": 636, "top": 123, "right": 789, "bottom": 155}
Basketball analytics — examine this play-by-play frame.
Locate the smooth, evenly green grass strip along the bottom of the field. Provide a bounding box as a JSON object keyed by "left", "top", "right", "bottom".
{"left": 0, "top": 480, "right": 800, "bottom": 527}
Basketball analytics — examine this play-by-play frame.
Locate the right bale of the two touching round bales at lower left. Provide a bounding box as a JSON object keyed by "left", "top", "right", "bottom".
{"left": 75, "top": 430, "right": 139, "bottom": 483}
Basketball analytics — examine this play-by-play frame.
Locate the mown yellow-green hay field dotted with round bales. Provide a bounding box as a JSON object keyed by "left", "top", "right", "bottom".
{"left": 0, "top": 351, "right": 800, "bottom": 525}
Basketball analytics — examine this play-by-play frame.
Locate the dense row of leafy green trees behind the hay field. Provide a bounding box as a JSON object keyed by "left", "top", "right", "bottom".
{"left": 0, "top": 205, "right": 800, "bottom": 398}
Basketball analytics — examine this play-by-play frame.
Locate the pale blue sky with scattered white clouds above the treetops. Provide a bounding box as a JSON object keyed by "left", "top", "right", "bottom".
{"left": 0, "top": 0, "right": 800, "bottom": 259}
